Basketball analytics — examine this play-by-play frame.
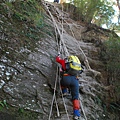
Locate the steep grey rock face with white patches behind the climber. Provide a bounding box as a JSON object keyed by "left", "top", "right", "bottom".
{"left": 0, "top": 0, "right": 119, "bottom": 120}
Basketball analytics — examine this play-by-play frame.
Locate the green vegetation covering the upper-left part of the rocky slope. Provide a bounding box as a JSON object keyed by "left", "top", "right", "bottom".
{"left": 0, "top": 0, "right": 54, "bottom": 53}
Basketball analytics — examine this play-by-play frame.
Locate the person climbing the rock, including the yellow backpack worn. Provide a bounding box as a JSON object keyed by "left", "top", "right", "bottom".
{"left": 56, "top": 54, "right": 83, "bottom": 120}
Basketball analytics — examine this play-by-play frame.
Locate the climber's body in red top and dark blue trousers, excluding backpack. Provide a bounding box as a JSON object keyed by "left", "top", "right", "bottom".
{"left": 56, "top": 54, "right": 83, "bottom": 120}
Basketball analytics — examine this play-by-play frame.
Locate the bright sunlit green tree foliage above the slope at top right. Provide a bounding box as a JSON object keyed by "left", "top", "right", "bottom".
{"left": 71, "top": 0, "right": 114, "bottom": 25}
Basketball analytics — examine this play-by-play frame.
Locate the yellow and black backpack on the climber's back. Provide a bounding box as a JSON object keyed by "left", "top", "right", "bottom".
{"left": 66, "top": 55, "right": 82, "bottom": 76}
